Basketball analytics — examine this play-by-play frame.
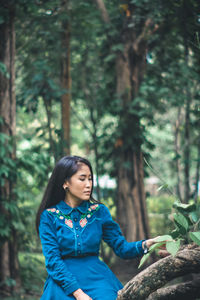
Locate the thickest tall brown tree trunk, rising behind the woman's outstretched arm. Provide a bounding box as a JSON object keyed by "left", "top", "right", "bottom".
{"left": 96, "top": 1, "right": 162, "bottom": 241}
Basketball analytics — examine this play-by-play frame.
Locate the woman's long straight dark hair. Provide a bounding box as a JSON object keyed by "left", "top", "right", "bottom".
{"left": 36, "top": 156, "right": 97, "bottom": 232}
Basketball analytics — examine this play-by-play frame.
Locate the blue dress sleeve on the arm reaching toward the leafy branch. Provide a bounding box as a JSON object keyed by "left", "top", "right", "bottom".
{"left": 102, "top": 205, "right": 144, "bottom": 259}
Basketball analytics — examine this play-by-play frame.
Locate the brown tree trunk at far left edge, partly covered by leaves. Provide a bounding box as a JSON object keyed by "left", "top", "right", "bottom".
{"left": 0, "top": 2, "right": 20, "bottom": 294}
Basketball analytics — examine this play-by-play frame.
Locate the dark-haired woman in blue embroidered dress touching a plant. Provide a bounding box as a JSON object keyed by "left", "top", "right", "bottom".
{"left": 36, "top": 156, "right": 158, "bottom": 300}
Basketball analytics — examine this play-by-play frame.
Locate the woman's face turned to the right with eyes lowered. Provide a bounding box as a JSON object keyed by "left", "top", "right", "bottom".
{"left": 63, "top": 163, "right": 92, "bottom": 204}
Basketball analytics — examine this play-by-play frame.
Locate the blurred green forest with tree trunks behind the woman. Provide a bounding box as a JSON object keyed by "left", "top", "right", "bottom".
{"left": 0, "top": 0, "right": 200, "bottom": 299}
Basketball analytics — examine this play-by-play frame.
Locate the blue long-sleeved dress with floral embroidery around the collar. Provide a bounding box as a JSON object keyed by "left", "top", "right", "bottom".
{"left": 39, "top": 201, "right": 144, "bottom": 300}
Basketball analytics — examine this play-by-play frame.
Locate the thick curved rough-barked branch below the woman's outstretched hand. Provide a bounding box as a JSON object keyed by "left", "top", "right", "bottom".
{"left": 117, "top": 247, "right": 200, "bottom": 300}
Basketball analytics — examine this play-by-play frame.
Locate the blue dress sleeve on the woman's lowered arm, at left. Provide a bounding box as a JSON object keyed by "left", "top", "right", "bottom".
{"left": 39, "top": 211, "right": 80, "bottom": 295}
